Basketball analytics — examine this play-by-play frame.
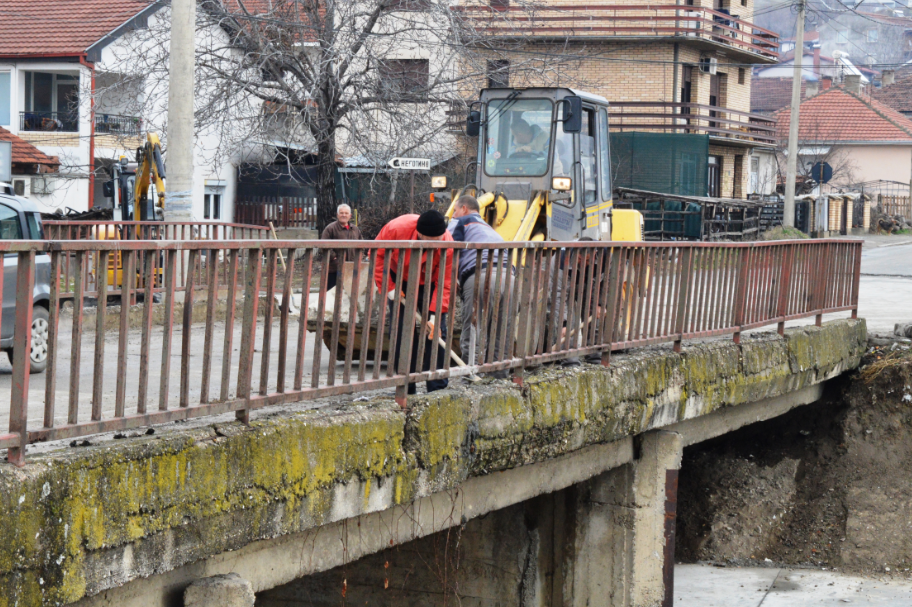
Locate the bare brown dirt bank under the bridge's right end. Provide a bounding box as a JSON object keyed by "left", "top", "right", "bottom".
{"left": 676, "top": 345, "right": 912, "bottom": 573}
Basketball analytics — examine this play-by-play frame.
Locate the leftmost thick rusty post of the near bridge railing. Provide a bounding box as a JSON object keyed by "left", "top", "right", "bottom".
{"left": 6, "top": 251, "right": 35, "bottom": 467}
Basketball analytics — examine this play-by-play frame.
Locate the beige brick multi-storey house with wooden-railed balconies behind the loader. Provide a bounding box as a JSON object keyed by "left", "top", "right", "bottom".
{"left": 461, "top": 0, "right": 779, "bottom": 198}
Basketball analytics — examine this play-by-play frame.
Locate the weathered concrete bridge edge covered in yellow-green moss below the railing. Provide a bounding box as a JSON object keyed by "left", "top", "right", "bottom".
{"left": 0, "top": 321, "right": 865, "bottom": 607}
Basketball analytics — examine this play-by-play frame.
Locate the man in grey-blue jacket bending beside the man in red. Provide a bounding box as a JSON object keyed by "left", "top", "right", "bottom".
{"left": 449, "top": 196, "right": 512, "bottom": 378}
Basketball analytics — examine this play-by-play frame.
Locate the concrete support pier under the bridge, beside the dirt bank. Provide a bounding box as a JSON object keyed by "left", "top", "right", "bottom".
{"left": 554, "top": 431, "right": 683, "bottom": 607}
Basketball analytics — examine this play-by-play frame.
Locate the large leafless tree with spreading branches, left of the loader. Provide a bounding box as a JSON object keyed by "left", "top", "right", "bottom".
{"left": 97, "top": 0, "right": 579, "bottom": 226}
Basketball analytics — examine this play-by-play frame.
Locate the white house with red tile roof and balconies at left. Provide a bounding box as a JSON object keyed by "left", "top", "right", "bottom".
{"left": 0, "top": 0, "right": 254, "bottom": 221}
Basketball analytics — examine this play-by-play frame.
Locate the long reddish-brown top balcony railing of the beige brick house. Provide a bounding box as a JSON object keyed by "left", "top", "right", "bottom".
{"left": 454, "top": 3, "right": 779, "bottom": 60}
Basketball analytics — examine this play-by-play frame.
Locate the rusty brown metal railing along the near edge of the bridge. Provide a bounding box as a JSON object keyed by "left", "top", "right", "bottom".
{"left": 0, "top": 240, "right": 861, "bottom": 465}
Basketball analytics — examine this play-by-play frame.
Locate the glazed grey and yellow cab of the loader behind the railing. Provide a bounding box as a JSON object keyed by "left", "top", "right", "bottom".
{"left": 456, "top": 88, "right": 612, "bottom": 241}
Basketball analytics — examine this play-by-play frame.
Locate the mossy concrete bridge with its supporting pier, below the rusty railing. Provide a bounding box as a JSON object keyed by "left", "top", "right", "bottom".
{"left": 0, "top": 318, "right": 866, "bottom": 607}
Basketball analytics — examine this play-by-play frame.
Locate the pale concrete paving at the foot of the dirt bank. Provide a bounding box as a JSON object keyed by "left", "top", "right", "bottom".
{"left": 674, "top": 565, "right": 912, "bottom": 607}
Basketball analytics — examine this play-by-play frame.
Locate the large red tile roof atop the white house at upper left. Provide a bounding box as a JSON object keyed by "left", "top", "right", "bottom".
{"left": 0, "top": 0, "right": 150, "bottom": 57}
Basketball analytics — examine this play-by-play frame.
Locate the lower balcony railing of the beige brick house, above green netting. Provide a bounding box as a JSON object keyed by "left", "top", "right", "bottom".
{"left": 608, "top": 102, "right": 777, "bottom": 146}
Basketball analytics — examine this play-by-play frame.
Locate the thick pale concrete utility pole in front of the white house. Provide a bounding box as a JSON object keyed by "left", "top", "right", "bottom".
{"left": 165, "top": 0, "right": 196, "bottom": 221}
